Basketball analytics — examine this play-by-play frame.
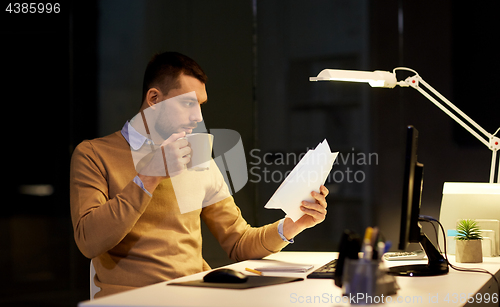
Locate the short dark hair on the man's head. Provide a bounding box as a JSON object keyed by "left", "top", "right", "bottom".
{"left": 141, "top": 52, "right": 208, "bottom": 105}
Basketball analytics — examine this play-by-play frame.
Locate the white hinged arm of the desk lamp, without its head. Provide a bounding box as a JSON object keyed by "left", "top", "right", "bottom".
{"left": 402, "top": 73, "right": 500, "bottom": 183}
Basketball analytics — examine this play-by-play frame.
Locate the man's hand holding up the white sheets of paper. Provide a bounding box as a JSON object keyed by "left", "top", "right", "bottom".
{"left": 283, "top": 185, "right": 329, "bottom": 240}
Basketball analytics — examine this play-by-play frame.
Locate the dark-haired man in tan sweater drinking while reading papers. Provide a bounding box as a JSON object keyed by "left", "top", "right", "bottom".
{"left": 70, "top": 52, "right": 328, "bottom": 297}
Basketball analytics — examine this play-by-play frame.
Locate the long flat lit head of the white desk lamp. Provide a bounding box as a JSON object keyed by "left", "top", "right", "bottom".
{"left": 309, "top": 69, "right": 398, "bottom": 88}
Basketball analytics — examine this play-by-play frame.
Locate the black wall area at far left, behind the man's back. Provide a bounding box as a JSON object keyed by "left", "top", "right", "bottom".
{"left": 0, "top": 1, "right": 97, "bottom": 306}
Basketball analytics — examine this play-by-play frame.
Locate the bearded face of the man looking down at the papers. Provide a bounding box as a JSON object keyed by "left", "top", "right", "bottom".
{"left": 155, "top": 74, "right": 207, "bottom": 139}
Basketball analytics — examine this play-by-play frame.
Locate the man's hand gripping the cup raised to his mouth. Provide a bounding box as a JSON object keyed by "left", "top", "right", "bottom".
{"left": 138, "top": 131, "right": 191, "bottom": 193}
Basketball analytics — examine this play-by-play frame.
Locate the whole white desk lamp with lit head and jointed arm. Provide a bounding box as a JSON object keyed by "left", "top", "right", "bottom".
{"left": 309, "top": 67, "right": 500, "bottom": 183}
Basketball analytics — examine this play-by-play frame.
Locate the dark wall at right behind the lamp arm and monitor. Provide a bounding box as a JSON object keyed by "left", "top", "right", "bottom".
{"left": 371, "top": 1, "right": 500, "bottom": 248}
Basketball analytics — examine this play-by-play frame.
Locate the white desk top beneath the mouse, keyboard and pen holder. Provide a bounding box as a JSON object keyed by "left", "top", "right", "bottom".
{"left": 79, "top": 252, "right": 500, "bottom": 307}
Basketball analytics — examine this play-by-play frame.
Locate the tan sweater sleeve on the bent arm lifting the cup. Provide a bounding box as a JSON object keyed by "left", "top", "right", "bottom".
{"left": 70, "top": 141, "right": 151, "bottom": 258}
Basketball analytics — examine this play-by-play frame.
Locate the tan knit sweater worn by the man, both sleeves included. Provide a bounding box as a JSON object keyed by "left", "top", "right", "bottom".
{"left": 70, "top": 131, "right": 287, "bottom": 297}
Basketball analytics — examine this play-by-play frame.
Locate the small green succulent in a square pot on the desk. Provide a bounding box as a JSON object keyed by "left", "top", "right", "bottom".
{"left": 455, "top": 219, "right": 483, "bottom": 263}
